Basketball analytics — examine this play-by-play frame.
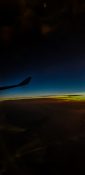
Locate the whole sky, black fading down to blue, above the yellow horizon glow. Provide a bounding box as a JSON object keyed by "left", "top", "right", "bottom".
{"left": 0, "top": 0, "right": 85, "bottom": 96}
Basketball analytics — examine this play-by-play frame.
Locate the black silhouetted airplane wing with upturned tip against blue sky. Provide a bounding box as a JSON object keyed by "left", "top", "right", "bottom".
{"left": 0, "top": 76, "right": 32, "bottom": 91}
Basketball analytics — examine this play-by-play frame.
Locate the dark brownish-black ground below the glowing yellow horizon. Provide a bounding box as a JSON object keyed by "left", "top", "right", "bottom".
{"left": 0, "top": 99, "right": 85, "bottom": 175}
